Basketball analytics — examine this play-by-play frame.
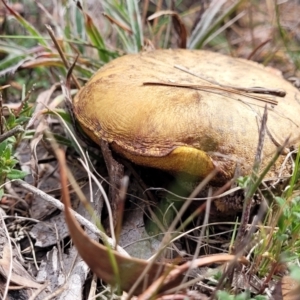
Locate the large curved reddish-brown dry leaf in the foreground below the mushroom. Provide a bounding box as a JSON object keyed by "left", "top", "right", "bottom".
{"left": 57, "top": 150, "right": 181, "bottom": 294}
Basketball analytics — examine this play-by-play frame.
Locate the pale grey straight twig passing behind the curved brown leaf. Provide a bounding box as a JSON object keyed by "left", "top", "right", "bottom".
{"left": 13, "top": 179, "right": 130, "bottom": 257}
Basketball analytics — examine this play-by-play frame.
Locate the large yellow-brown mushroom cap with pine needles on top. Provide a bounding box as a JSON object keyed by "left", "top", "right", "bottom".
{"left": 73, "top": 49, "right": 300, "bottom": 184}
